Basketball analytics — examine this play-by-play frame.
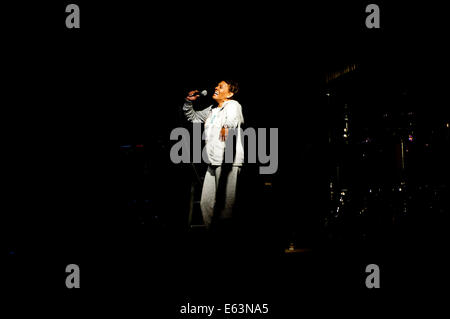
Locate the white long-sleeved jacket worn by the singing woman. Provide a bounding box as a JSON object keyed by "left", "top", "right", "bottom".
{"left": 183, "top": 100, "right": 244, "bottom": 166}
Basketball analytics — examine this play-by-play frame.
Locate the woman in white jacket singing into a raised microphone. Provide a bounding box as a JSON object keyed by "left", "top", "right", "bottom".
{"left": 183, "top": 80, "right": 244, "bottom": 229}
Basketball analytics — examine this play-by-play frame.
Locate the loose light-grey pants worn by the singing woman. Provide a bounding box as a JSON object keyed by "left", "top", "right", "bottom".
{"left": 200, "top": 165, "right": 241, "bottom": 229}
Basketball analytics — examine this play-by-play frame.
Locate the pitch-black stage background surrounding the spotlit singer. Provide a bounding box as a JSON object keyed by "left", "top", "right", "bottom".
{"left": 1, "top": 0, "right": 450, "bottom": 318}
